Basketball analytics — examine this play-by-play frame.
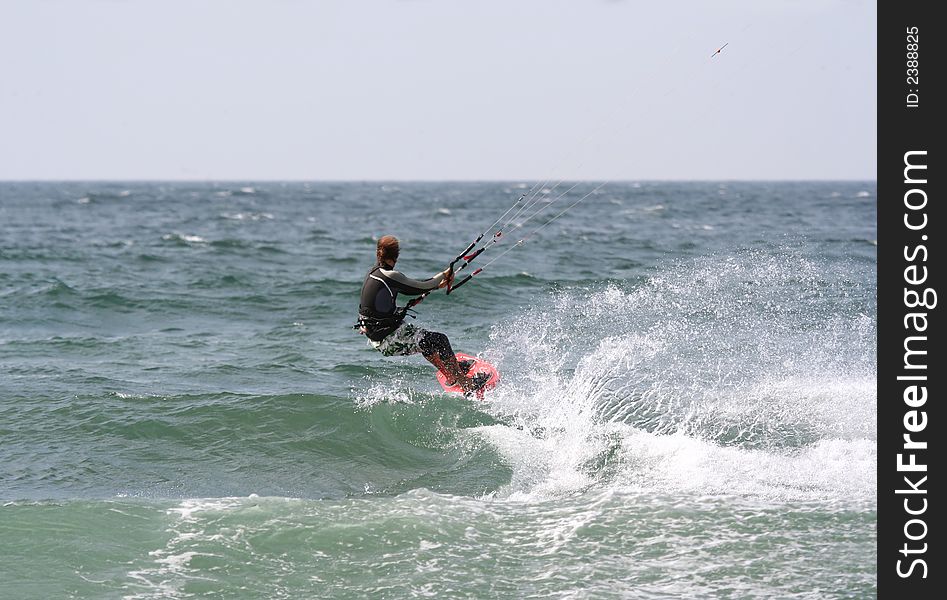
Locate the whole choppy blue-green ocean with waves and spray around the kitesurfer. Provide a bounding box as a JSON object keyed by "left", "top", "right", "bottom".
{"left": 0, "top": 181, "right": 877, "bottom": 599}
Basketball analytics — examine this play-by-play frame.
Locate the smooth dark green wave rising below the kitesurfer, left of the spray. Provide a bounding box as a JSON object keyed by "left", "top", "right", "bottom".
{"left": 0, "top": 390, "right": 508, "bottom": 499}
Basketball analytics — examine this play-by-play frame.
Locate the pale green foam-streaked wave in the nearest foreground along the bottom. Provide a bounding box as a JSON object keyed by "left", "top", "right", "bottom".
{"left": 0, "top": 489, "right": 876, "bottom": 599}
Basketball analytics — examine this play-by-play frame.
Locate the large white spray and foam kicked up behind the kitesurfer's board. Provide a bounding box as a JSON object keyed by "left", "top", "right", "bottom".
{"left": 478, "top": 251, "right": 877, "bottom": 502}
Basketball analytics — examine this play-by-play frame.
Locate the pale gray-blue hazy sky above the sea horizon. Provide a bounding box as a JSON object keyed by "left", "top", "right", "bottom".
{"left": 0, "top": 0, "right": 877, "bottom": 181}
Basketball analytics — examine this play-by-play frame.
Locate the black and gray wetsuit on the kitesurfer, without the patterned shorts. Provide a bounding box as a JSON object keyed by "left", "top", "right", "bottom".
{"left": 358, "top": 263, "right": 453, "bottom": 356}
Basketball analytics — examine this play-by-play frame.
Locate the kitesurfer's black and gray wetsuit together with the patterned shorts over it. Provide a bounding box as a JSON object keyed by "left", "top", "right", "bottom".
{"left": 358, "top": 263, "right": 454, "bottom": 359}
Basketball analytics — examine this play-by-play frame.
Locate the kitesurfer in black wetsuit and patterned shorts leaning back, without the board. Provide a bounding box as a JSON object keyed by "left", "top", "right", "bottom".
{"left": 358, "top": 235, "right": 486, "bottom": 394}
